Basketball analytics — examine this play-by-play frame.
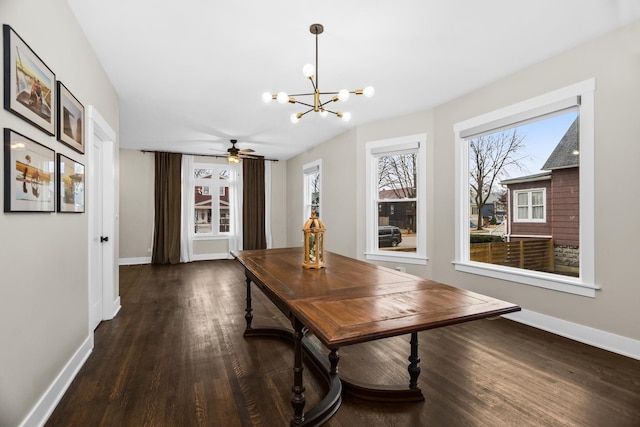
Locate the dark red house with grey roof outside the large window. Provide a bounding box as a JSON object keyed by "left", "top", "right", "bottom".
{"left": 502, "top": 118, "right": 580, "bottom": 276}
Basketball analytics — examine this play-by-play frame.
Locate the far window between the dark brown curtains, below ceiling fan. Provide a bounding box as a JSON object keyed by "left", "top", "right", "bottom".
{"left": 193, "top": 164, "right": 233, "bottom": 237}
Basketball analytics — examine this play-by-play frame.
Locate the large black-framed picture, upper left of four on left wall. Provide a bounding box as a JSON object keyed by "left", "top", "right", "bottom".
{"left": 2, "top": 24, "right": 56, "bottom": 135}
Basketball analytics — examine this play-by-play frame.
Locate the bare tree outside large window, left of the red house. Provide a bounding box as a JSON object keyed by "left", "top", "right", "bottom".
{"left": 469, "top": 128, "right": 526, "bottom": 230}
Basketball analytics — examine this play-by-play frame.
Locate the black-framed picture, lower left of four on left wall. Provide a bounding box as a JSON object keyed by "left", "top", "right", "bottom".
{"left": 4, "top": 129, "right": 56, "bottom": 212}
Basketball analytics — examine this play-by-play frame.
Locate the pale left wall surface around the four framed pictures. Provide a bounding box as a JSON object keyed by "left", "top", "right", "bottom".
{"left": 0, "top": 0, "right": 118, "bottom": 426}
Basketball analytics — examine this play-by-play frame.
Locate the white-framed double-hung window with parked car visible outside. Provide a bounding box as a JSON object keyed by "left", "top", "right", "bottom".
{"left": 365, "top": 134, "right": 427, "bottom": 264}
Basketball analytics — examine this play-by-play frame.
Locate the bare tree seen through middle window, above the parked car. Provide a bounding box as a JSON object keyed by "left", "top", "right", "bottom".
{"left": 378, "top": 153, "right": 417, "bottom": 199}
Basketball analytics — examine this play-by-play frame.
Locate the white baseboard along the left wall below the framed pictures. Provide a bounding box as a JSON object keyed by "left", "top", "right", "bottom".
{"left": 20, "top": 331, "right": 93, "bottom": 427}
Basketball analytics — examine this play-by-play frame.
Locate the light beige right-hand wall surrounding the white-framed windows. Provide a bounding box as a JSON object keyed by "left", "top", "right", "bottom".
{"left": 287, "top": 22, "right": 640, "bottom": 348}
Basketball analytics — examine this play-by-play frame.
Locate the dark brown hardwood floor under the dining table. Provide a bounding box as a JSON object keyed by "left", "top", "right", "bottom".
{"left": 46, "top": 260, "right": 640, "bottom": 427}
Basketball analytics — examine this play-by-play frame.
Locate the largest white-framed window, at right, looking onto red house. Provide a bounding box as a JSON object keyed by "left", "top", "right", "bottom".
{"left": 454, "top": 80, "right": 598, "bottom": 296}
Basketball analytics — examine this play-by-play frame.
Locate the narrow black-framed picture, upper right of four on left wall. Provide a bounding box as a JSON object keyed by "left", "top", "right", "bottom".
{"left": 57, "top": 82, "right": 84, "bottom": 153}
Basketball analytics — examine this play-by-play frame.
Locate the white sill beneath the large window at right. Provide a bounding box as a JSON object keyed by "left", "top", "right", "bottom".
{"left": 454, "top": 261, "right": 600, "bottom": 298}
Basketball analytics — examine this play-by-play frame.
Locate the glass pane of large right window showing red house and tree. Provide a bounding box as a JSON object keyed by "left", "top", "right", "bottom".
{"left": 467, "top": 110, "right": 580, "bottom": 276}
